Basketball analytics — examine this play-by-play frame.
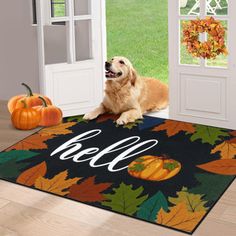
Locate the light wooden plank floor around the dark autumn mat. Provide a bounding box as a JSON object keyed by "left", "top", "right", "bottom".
{"left": 0, "top": 102, "right": 236, "bottom": 236}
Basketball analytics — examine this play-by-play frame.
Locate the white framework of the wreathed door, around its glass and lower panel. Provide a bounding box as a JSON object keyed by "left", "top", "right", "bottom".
{"left": 168, "top": 0, "right": 236, "bottom": 129}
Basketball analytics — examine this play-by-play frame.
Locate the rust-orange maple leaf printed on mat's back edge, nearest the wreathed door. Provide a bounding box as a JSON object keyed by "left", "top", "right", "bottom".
{"left": 153, "top": 120, "right": 195, "bottom": 137}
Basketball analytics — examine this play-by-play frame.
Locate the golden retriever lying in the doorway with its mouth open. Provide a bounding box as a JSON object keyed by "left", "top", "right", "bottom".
{"left": 84, "top": 57, "right": 169, "bottom": 125}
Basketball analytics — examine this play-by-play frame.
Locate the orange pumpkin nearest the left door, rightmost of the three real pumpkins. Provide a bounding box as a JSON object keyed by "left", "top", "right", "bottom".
{"left": 34, "top": 97, "right": 62, "bottom": 126}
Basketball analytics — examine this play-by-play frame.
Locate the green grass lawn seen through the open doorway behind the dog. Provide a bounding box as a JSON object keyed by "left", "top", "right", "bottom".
{"left": 106, "top": 0, "right": 168, "bottom": 83}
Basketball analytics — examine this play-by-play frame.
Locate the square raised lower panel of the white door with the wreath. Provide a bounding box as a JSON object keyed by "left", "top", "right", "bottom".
{"left": 180, "top": 74, "right": 226, "bottom": 119}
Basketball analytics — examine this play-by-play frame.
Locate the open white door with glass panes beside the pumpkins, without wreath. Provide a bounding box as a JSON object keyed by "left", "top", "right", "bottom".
{"left": 36, "top": 0, "right": 106, "bottom": 116}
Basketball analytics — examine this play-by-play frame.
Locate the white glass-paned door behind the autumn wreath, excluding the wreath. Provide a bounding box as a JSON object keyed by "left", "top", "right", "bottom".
{"left": 169, "top": 0, "right": 236, "bottom": 129}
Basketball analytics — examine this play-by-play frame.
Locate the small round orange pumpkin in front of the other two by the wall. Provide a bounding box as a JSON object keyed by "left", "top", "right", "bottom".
{"left": 11, "top": 100, "right": 41, "bottom": 130}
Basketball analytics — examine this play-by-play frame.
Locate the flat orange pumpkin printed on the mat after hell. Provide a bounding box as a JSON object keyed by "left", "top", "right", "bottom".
{"left": 128, "top": 156, "right": 181, "bottom": 181}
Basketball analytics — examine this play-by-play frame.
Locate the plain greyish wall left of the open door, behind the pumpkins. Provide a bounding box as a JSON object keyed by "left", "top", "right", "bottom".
{"left": 0, "top": 0, "right": 39, "bottom": 100}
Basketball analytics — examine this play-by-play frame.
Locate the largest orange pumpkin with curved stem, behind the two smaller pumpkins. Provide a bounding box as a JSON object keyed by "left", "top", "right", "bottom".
{"left": 7, "top": 83, "right": 52, "bottom": 114}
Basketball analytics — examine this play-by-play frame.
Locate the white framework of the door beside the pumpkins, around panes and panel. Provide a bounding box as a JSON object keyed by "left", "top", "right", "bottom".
{"left": 36, "top": 0, "right": 107, "bottom": 116}
